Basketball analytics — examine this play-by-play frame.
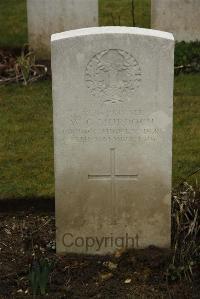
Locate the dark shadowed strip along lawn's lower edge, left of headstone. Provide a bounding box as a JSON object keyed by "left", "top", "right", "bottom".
{"left": 0, "top": 196, "right": 55, "bottom": 214}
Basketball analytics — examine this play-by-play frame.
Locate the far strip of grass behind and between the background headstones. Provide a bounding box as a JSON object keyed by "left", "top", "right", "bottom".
{"left": 0, "top": 0, "right": 151, "bottom": 48}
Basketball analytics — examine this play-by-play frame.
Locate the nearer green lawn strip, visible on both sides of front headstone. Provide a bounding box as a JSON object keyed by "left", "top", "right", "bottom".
{"left": 0, "top": 74, "right": 200, "bottom": 199}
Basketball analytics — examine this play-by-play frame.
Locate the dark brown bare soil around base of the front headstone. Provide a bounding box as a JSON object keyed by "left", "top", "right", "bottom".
{"left": 0, "top": 199, "right": 200, "bottom": 299}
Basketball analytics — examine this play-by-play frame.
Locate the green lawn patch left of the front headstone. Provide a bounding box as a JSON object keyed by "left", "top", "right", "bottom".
{"left": 0, "top": 81, "right": 54, "bottom": 198}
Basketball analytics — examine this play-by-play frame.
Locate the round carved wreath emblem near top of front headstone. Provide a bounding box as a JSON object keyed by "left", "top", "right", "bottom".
{"left": 85, "top": 49, "right": 142, "bottom": 103}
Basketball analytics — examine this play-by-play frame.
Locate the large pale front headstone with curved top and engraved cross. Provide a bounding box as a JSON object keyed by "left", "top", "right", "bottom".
{"left": 52, "top": 27, "right": 174, "bottom": 254}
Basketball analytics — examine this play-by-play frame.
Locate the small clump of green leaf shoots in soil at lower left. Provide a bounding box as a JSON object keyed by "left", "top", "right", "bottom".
{"left": 28, "top": 259, "right": 54, "bottom": 296}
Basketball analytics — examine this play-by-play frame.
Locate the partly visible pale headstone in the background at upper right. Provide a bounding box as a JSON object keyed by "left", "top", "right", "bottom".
{"left": 151, "top": 0, "right": 200, "bottom": 41}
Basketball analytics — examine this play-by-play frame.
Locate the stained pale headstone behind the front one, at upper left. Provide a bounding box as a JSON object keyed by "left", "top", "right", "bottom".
{"left": 27, "top": 0, "right": 98, "bottom": 59}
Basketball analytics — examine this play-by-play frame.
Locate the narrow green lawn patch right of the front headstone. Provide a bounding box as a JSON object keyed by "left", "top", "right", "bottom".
{"left": 173, "top": 74, "right": 200, "bottom": 188}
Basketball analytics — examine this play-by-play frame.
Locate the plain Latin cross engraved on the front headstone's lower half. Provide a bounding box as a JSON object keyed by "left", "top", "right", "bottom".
{"left": 88, "top": 148, "right": 138, "bottom": 203}
